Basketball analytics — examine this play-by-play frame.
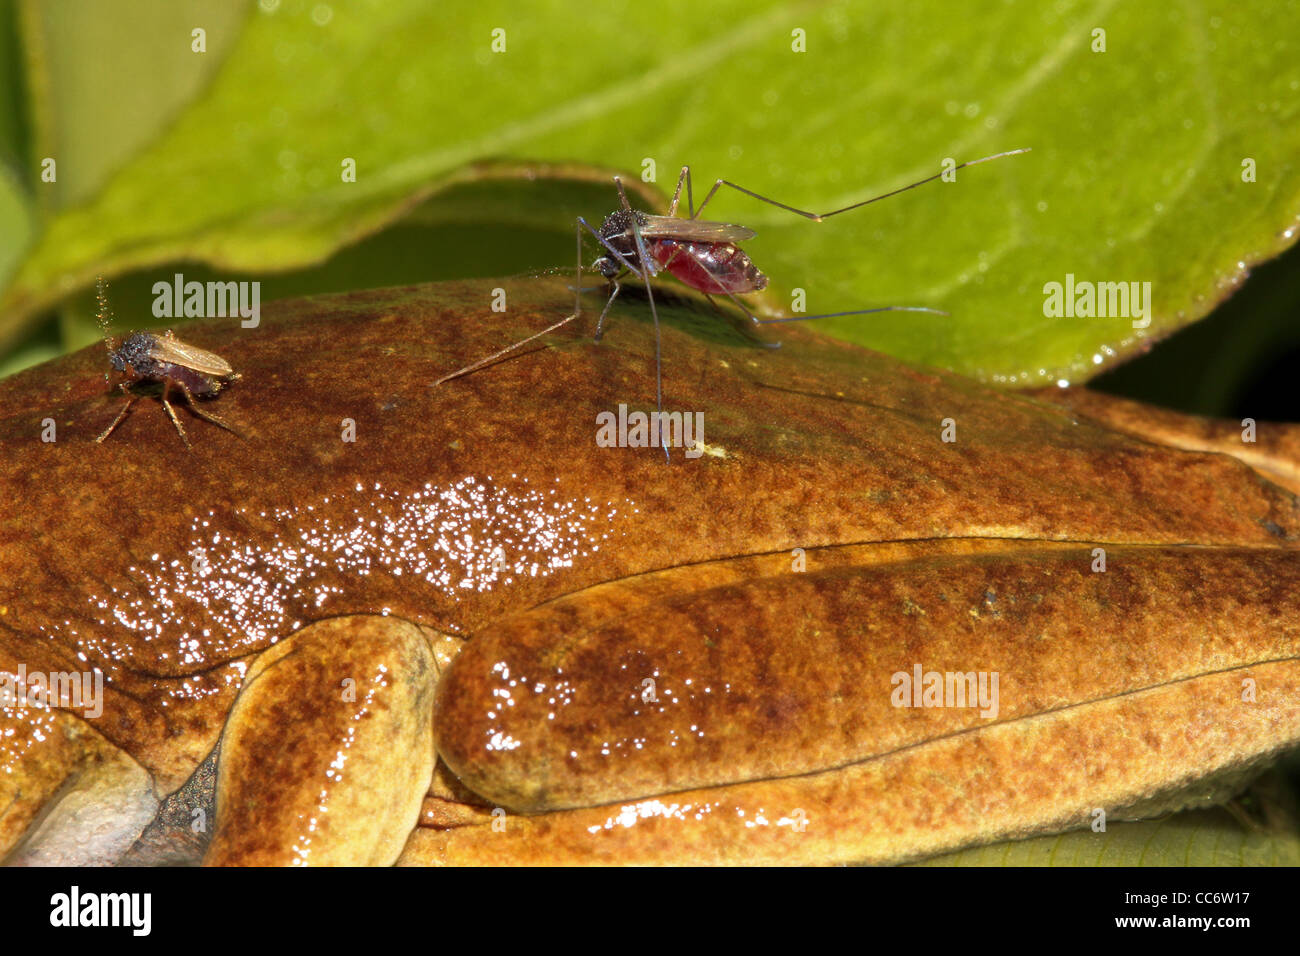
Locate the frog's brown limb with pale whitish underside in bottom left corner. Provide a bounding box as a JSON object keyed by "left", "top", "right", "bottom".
{"left": 0, "top": 704, "right": 159, "bottom": 866}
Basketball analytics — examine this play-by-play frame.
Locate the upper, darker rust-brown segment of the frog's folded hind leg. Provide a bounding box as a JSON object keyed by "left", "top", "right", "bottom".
{"left": 437, "top": 541, "right": 1300, "bottom": 812}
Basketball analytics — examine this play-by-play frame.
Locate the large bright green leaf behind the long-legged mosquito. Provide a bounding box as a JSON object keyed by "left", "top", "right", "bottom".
{"left": 0, "top": 0, "right": 1300, "bottom": 385}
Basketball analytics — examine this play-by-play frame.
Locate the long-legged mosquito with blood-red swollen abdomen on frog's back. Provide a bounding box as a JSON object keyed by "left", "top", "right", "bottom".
{"left": 434, "top": 147, "right": 1030, "bottom": 455}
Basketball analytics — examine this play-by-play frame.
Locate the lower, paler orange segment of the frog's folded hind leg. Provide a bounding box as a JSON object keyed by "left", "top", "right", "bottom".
{"left": 398, "top": 661, "right": 1300, "bottom": 865}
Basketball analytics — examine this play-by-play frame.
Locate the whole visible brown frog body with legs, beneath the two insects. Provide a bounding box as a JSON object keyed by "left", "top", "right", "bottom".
{"left": 0, "top": 282, "right": 1300, "bottom": 865}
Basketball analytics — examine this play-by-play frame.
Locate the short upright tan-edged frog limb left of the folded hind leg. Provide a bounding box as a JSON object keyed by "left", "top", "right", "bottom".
{"left": 204, "top": 615, "right": 438, "bottom": 866}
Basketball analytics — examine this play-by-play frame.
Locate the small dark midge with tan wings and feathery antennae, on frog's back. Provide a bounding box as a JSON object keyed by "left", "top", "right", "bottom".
{"left": 95, "top": 276, "right": 239, "bottom": 449}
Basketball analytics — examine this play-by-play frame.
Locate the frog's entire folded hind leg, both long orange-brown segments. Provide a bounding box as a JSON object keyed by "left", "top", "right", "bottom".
{"left": 400, "top": 538, "right": 1300, "bottom": 865}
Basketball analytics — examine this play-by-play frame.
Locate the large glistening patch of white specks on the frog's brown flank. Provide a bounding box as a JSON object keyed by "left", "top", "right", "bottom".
{"left": 46, "top": 476, "right": 636, "bottom": 700}
